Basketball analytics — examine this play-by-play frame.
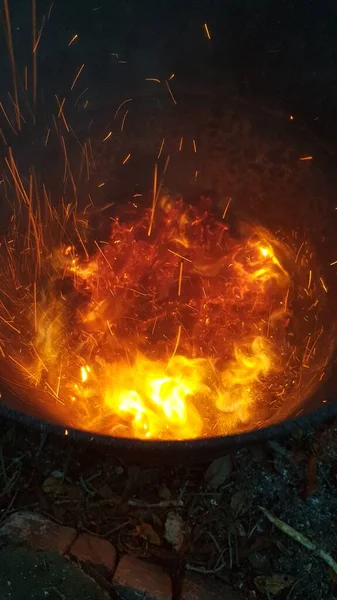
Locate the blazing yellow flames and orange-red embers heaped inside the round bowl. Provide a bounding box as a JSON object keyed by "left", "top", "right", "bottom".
{"left": 0, "top": 183, "right": 328, "bottom": 439}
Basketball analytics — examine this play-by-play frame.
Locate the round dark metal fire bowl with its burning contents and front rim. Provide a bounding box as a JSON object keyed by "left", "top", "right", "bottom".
{"left": 0, "top": 86, "right": 335, "bottom": 462}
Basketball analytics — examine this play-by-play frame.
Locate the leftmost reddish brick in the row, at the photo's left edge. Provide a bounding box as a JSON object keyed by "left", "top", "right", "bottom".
{"left": 0, "top": 511, "right": 77, "bottom": 554}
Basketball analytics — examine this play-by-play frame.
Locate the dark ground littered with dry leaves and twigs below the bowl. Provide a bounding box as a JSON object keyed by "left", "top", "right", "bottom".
{"left": 0, "top": 414, "right": 337, "bottom": 600}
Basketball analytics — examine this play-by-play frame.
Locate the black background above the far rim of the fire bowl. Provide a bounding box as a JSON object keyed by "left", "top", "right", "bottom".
{"left": 0, "top": 0, "right": 337, "bottom": 137}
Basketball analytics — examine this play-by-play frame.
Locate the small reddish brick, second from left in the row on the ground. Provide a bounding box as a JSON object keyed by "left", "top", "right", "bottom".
{"left": 69, "top": 533, "right": 116, "bottom": 574}
